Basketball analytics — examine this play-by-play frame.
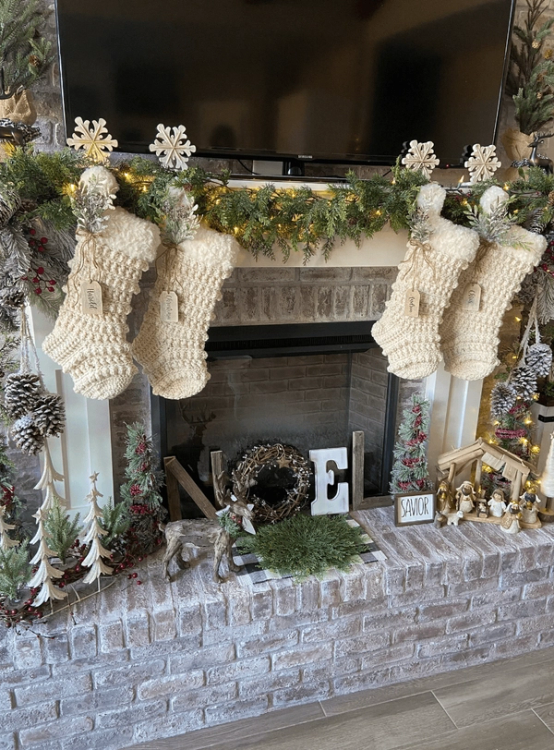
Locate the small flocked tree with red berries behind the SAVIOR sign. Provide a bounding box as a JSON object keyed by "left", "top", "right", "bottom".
{"left": 390, "top": 393, "right": 431, "bottom": 495}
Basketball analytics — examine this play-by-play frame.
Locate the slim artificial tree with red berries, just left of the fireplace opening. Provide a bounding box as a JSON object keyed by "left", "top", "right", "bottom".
{"left": 121, "top": 422, "right": 165, "bottom": 554}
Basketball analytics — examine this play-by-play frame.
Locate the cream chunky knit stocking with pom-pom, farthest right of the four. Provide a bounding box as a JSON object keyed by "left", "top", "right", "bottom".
{"left": 440, "top": 187, "right": 546, "bottom": 380}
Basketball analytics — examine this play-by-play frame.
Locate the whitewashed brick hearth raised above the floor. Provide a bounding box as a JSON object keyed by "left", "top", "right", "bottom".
{"left": 0, "top": 508, "right": 554, "bottom": 750}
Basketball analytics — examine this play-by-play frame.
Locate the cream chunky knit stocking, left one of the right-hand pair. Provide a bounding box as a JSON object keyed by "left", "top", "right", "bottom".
{"left": 372, "top": 183, "right": 479, "bottom": 379}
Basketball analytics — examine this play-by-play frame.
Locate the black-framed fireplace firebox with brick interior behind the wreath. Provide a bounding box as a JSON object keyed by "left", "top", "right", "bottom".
{"left": 153, "top": 323, "right": 398, "bottom": 512}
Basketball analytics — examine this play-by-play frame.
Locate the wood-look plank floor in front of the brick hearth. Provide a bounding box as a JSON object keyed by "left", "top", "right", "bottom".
{"left": 127, "top": 648, "right": 554, "bottom": 750}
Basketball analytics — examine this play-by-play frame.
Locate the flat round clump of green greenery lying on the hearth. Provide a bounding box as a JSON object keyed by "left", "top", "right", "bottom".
{"left": 237, "top": 513, "right": 365, "bottom": 580}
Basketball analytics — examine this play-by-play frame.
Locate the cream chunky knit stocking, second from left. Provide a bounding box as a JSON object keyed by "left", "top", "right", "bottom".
{"left": 133, "top": 227, "right": 238, "bottom": 399}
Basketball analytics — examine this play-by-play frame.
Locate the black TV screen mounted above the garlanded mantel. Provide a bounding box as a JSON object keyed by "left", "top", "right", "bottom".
{"left": 58, "top": 0, "right": 513, "bottom": 165}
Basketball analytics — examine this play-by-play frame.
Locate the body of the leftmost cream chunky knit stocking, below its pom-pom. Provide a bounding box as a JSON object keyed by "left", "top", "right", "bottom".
{"left": 43, "top": 208, "right": 160, "bottom": 399}
